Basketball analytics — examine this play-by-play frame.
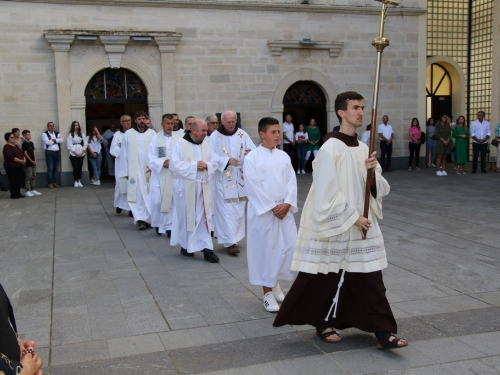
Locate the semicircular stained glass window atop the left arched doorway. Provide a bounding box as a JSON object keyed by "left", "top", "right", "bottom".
{"left": 85, "top": 69, "right": 148, "bottom": 102}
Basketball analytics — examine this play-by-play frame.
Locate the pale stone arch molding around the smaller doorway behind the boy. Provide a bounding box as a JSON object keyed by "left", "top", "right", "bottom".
{"left": 271, "top": 68, "right": 337, "bottom": 129}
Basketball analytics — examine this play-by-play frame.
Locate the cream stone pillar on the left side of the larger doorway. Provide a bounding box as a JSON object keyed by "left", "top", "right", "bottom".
{"left": 45, "top": 34, "right": 75, "bottom": 186}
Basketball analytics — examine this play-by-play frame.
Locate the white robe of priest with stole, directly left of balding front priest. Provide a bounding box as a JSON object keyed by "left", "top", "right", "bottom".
{"left": 148, "top": 130, "right": 179, "bottom": 233}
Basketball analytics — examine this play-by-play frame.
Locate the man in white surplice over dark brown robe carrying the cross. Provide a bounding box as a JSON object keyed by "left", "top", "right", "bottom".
{"left": 274, "top": 91, "right": 408, "bottom": 349}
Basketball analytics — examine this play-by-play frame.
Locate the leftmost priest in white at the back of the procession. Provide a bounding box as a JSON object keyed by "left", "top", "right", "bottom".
{"left": 109, "top": 115, "right": 132, "bottom": 214}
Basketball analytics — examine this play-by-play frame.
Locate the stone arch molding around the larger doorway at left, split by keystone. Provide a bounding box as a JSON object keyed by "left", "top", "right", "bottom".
{"left": 71, "top": 55, "right": 163, "bottom": 128}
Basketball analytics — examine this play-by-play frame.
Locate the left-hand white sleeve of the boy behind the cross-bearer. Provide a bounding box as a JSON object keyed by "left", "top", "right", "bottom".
{"left": 243, "top": 154, "right": 276, "bottom": 216}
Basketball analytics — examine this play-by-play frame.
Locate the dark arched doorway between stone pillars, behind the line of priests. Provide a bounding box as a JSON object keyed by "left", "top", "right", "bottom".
{"left": 85, "top": 68, "right": 148, "bottom": 181}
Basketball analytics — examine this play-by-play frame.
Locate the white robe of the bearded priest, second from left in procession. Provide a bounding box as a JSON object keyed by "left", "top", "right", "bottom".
{"left": 118, "top": 129, "right": 156, "bottom": 224}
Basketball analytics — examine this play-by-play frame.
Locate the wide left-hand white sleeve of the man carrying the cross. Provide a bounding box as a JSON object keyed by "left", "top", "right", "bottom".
{"left": 311, "top": 147, "right": 360, "bottom": 238}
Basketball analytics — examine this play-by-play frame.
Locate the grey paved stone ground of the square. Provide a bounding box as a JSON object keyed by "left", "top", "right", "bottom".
{"left": 0, "top": 170, "right": 500, "bottom": 375}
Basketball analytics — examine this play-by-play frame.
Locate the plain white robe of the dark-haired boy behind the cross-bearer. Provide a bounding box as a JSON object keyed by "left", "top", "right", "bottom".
{"left": 243, "top": 146, "right": 297, "bottom": 288}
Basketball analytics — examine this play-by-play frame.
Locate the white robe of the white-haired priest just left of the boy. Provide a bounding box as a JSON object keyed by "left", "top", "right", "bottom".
{"left": 210, "top": 129, "right": 255, "bottom": 247}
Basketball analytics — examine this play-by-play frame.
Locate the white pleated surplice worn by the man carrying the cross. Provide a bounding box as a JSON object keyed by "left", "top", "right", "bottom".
{"left": 292, "top": 138, "right": 390, "bottom": 274}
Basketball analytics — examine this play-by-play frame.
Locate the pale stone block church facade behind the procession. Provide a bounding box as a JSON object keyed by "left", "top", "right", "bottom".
{"left": 0, "top": 0, "right": 426, "bottom": 185}
